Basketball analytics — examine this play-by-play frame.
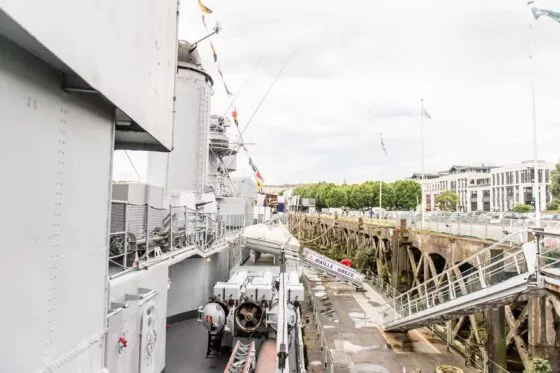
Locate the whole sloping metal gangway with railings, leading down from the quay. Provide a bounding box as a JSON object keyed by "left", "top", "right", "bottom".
{"left": 382, "top": 231, "right": 560, "bottom": 331}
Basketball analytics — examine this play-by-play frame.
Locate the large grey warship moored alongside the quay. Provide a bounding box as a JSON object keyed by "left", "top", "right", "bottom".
{"left": 0, "top": 0, "right": 359, "bottom": 373}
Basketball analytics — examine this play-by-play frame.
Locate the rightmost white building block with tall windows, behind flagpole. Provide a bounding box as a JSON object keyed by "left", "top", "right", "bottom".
{"left": 491, "top": 161, "right": 554, "bottom": 211}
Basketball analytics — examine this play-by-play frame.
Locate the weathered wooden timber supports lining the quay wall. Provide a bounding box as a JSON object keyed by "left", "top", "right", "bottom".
{"left": 288, "top": 213, "right": 560, "bottom": 373}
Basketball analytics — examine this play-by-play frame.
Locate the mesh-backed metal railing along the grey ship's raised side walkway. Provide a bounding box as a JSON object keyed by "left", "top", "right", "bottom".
{"left": 109, "top": 201, "right": 246, "bottom": 272}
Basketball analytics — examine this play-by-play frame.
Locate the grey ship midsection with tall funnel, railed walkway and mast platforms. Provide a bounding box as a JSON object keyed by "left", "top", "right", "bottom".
{"left": 106, "top": 41, "right": 256, "bottom": 372}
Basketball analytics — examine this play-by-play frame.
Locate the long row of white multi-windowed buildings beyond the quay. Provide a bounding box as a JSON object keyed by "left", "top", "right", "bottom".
{"left": 411, "top": 161, "right": 554, "bottom": 212}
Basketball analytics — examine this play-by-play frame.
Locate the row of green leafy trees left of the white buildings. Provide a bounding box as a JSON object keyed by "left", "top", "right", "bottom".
{"left": 293, "top": 180, "right": 422, "bottom": 210}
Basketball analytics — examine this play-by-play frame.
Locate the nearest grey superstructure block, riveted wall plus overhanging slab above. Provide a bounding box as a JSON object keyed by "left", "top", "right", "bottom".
{"left": 0, "top": 0, "right": 178, "bottom": 373}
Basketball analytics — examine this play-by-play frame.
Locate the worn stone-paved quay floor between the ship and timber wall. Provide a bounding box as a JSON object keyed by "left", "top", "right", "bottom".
{"left": 303, "top": 273, "right": 477, "bottom": 373}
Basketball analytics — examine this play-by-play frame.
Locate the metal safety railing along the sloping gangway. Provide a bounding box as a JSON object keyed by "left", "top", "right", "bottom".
{"left": 382, "top": 232, "right": 528, "bottom": 328}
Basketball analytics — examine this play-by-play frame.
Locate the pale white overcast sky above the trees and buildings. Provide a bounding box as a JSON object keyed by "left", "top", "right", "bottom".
{"left": 115, "top": 0, "right": 560, "bottom": 184}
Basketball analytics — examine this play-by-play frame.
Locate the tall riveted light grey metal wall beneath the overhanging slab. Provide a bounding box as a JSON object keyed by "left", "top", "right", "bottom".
{"left": 0, "top": 35, "right": 113, "bottom": 373}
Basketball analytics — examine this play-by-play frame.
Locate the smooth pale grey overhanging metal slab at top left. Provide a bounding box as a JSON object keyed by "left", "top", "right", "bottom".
{"left": 0, "top": 0, "right": 178, "bottom": 149}
